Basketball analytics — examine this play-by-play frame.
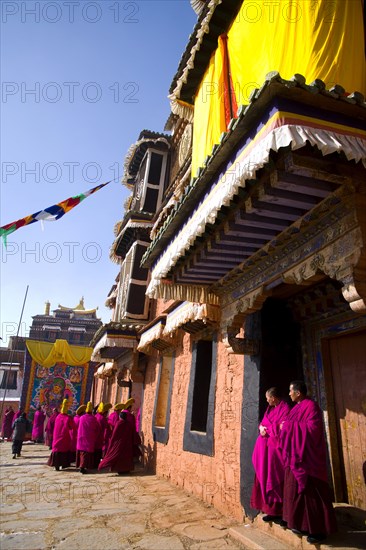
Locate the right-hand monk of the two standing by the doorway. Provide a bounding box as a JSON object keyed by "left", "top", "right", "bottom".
{"left": 280, "top": 380, "right": 337, "bottom": 544}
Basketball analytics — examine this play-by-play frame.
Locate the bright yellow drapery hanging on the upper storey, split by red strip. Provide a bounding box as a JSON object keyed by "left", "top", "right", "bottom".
{"left": 192, "top": 0, "right": 366, "bottom": 176}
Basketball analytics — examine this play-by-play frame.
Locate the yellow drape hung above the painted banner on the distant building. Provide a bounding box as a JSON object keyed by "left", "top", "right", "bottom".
{"left": 26, "top": 340, "right": 93, "bottom": 367}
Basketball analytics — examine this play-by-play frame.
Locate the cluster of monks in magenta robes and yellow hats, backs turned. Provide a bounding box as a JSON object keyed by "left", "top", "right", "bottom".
{"left": 47, "top": 398, "right": 141, "bottom": 475}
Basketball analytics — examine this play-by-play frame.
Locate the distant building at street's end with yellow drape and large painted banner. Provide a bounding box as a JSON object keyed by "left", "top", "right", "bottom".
{"left": 20, "top": 298, "right": 102, "bottom": 417}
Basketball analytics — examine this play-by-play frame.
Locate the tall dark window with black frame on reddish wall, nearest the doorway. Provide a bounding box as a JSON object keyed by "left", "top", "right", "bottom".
{"left": 183, "top": 339, "right": 217, "bottom": 456}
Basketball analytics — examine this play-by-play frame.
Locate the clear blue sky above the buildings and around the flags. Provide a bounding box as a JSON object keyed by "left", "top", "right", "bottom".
{"left": 0, "top": 0, "right": 196, "bottom": 345}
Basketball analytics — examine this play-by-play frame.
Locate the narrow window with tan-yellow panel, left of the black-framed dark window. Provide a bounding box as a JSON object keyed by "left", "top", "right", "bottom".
{"left": 153, "top": 355, "right": 174, "bottom": 443}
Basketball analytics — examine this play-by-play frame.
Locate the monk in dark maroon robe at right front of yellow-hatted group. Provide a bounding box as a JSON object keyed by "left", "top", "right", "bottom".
{"left": 98, "top": 412, "right": 134, "bottom": 475}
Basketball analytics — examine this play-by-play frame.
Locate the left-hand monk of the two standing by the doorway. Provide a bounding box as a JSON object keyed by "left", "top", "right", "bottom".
{"left": 250, "top": 388, "right": 290, "bottom": 523}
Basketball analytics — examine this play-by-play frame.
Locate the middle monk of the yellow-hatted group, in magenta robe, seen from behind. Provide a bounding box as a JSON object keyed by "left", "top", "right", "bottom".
{"left": 76, "top": 401, "right": 100, "bottom": 474}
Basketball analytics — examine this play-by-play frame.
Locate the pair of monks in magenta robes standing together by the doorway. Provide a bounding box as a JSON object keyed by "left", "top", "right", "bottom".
{"left": 251, "top": 380, "right": 337, "bottom": 544}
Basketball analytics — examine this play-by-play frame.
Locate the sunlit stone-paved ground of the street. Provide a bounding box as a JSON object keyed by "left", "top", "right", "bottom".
{"left": 0, "top": 442, "right": 249, "bottom": 550}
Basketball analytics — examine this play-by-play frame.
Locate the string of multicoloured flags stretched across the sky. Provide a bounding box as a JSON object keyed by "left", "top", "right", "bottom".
{"left": 0, "top": 180, "right": 112, "bottom": 244}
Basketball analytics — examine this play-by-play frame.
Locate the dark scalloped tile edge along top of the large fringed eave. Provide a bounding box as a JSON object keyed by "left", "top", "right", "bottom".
{"left": 143, "top": 72, "right": 366, "bottom": 267}
